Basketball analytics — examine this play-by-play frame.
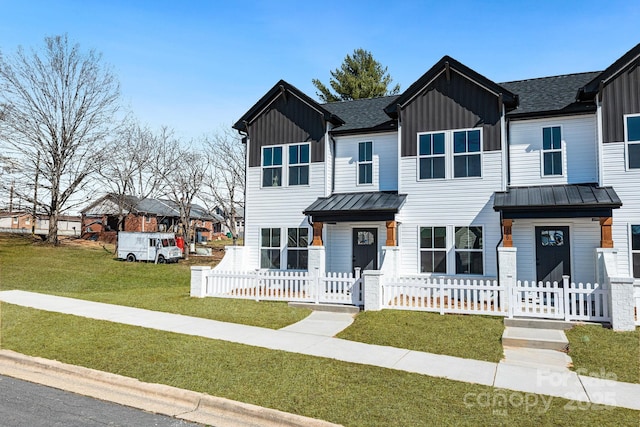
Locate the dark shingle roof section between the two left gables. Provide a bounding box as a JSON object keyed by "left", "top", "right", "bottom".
{"left": 322, "top": 95, "right": 399, "bottom": 133}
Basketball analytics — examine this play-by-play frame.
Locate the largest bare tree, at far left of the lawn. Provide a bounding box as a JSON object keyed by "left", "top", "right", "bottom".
{"left": 0, "top": 35, "right": 119, "bottom": 244}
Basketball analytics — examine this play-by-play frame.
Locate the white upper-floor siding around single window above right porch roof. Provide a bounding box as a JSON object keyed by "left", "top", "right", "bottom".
{"left": 509, "top": 115, "right": 598, "bottom": 187}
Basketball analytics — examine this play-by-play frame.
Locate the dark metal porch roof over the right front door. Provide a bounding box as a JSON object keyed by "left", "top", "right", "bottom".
{"left": 493, "top": 183, "right": 622, "bottom": 219}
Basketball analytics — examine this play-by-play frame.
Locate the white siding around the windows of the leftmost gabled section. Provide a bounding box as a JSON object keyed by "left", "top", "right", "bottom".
{"left": 244, "top": 163, "right": 326, "bottom": 268}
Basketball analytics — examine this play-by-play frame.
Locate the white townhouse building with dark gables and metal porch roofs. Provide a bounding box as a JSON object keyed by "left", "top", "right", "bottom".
{"left": 233, "top": 44, "right": 640, "bottom": 288}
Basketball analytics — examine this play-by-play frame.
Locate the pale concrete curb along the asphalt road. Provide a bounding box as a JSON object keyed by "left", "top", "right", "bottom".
{"left": 0, "top": 350, "right": 337, "bottom": 427}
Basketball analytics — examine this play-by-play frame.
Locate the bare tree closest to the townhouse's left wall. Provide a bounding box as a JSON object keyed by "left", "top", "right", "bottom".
{"left": 205, "top": 130, "right": 246, "bottom": 245}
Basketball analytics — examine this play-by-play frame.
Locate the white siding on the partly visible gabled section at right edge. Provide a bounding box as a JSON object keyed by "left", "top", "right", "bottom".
{"left": 602, "top": 142, "right": 640, "bottom": 285}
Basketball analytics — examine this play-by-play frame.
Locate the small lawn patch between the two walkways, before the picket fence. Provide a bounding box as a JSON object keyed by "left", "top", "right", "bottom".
{"left": 338, "top": 310, "right": 504, "bottom": 362}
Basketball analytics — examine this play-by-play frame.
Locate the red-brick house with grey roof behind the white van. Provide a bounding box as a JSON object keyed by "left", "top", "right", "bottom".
{"left": 81, "top": 194, "right": 221, "bottom": 242}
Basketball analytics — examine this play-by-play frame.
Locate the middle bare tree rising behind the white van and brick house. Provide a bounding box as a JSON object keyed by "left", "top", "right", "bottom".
{"left": 99, "top": 116, "right": 166, "bottom": 231}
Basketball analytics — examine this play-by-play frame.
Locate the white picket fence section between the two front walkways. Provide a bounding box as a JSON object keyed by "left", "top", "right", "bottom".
{"left": 382, "top": 276, "right": 508, "bottom": 316}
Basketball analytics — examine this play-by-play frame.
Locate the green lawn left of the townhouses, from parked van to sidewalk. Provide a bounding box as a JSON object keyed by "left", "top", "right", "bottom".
{"left": 0, "top": 234, "right": 310, "bottom": 329}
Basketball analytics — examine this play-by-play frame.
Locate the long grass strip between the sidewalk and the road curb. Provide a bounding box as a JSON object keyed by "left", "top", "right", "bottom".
{"left": 0, "top": 304, "right": 640, "bottom": 427}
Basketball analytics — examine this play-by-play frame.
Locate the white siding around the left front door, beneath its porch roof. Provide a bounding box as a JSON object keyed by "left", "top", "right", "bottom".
{"left": 325, "top": 222, "right": 387, "bottom": 273}
